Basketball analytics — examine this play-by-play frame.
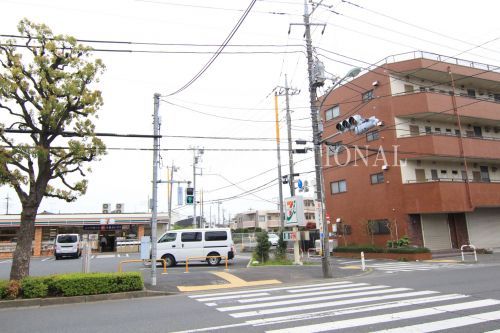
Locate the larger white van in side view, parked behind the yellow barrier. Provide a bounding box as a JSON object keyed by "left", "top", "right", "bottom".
{"left": 156, "top": 228, "right": 235, "bottom": 267}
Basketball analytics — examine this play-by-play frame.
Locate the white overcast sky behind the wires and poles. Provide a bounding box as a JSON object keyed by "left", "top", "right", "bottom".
{"left": 0, "top": 0, "right": 500, "bottom": 218}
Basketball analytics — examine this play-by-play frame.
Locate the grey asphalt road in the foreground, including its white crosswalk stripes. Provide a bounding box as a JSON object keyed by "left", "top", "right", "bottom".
{"left": 0, "top": 255, "right": 500, "bottom": 333}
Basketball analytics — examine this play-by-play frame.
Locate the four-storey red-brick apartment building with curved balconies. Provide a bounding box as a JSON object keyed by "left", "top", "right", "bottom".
{"left": 320, "top": 52, "right": 500, "bottom": 250}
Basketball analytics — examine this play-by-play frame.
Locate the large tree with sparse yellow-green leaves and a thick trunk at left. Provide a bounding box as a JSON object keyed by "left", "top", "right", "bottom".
{"left": 0, "top": 19, "right": 106, "bottom": 280}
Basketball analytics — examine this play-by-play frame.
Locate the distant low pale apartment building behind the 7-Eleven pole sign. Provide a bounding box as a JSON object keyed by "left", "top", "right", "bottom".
{"left": 231, "top": 198, "right": 316, "bottom": 232}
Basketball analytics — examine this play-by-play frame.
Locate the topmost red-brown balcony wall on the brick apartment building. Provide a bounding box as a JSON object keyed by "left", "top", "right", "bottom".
{"left": 391, "top": 92, "right": 500, "bottom": 120}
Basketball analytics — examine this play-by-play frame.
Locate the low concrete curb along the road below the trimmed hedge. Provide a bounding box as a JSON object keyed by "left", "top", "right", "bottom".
{"left": 0, "top": 290, "right": 176, "bottom": 309}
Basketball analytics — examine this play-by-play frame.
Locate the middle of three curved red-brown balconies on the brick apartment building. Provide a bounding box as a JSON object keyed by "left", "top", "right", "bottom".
{"left": 398, "top": 134, "right": 500, "bottom": 159}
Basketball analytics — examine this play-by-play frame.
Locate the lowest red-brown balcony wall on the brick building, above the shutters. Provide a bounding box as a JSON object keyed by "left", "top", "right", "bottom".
{"left": 403, "top": 179, "right": 500, "bottom": 214}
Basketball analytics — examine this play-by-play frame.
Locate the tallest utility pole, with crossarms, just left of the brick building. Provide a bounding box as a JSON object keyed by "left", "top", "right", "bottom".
{"left": 290, "top": 0, "right": 332, "bottom": 278}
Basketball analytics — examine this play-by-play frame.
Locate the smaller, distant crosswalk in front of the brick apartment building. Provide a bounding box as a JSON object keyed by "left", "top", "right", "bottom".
{"left": 338, "top": 259, "right": 468, "bottom": 274}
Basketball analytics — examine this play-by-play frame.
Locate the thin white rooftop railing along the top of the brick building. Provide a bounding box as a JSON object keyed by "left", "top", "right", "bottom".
{"left": 377, "top": 51, "right": 500, "bottom": 73}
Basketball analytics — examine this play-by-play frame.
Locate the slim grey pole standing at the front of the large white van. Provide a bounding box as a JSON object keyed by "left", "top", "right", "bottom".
{"left": 151, "top": 94, "right": 160, "bottom": 286}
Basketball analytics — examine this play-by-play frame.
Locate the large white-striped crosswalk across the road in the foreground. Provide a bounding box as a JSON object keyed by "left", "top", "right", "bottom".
{"left": 178, "top": 281, "right": 500, "bottom": 333}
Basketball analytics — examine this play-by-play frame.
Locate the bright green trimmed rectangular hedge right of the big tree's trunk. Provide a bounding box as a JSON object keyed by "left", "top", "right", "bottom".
{"left": 48, "top": 272, "right": 143, "bottom": 296}
